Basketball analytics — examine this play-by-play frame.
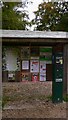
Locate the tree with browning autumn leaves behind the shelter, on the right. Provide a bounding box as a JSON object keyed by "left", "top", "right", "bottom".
{"left": 32, "top": 2, "right": 68, "bottom": 31}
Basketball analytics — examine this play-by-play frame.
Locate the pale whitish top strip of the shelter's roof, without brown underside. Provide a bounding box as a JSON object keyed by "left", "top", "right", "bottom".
{"left": 0, "top": 30, "right": 68, "bottom": 39}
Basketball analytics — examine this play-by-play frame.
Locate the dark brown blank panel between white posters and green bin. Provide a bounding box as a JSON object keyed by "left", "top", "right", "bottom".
{"left": 46, "top": 64, "right": 52, "bottom": 81}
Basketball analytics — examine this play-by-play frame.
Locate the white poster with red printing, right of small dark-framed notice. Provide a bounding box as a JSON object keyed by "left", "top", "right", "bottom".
{"left": 30, "top": 60, "right": 39, "bottom": 72}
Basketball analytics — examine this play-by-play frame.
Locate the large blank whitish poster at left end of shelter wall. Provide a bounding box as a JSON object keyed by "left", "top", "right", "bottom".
{"left": 6, "top": 47, "right": 18, "bottom": 71}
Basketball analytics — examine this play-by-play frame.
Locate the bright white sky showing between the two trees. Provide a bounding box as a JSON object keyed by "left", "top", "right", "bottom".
{"left": 18, "top": 0, "right": 51, "bottom": 31}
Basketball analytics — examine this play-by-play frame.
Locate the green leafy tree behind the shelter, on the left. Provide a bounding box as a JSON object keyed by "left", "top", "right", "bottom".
{"left": 2, "top": 2, "right": 29, "bottom": 30}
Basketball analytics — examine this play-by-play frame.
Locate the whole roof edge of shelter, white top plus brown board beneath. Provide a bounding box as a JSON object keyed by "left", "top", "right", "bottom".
{"left": 0, "top": 30, "right": 68, "bottom": 43}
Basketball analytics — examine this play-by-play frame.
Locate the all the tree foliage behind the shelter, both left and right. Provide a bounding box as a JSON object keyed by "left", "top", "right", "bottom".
{"left": 1, "top": 2, "right": 68, "bottom": 32}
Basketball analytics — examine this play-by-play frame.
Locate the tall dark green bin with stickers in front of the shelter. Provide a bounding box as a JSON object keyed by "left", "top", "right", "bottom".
{"left": 52, "top": 52, "right": 63, "bottom": 103}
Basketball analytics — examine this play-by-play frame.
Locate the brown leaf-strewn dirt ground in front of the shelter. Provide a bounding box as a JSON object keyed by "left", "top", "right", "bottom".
{"left": 2, "top": 82, "right": 67, "bottom": 118}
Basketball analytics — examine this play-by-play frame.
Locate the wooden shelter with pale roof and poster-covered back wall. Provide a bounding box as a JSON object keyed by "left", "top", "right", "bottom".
{"left": 0, "top": 30, "right": 68, "bottom": 93}
